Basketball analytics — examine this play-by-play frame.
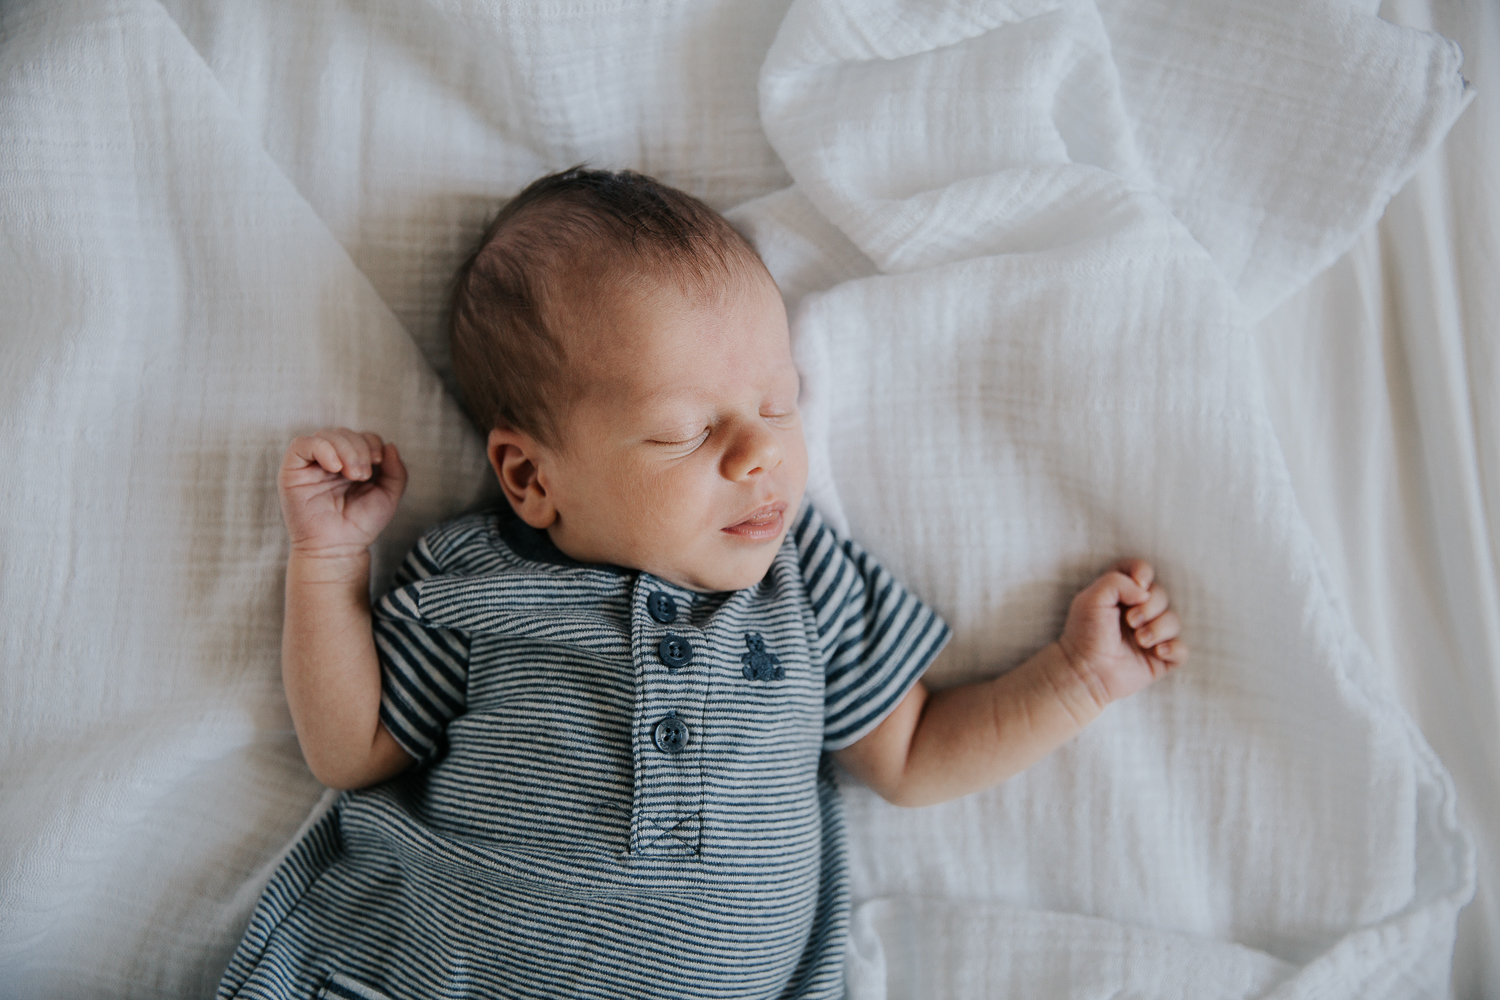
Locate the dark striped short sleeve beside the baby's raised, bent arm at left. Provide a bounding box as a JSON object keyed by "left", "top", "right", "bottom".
{"left": 374, "top": 538, "right": 470, "bottom": 760}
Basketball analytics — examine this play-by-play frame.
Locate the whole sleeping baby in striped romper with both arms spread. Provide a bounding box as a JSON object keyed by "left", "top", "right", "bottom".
{"left": 219, "top": 169, "right": 1188, "bottom": 1000}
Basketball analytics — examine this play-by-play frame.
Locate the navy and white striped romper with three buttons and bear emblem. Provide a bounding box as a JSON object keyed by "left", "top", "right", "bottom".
{"left": 219, "top": 505, "right": 948, "bottom": 1000}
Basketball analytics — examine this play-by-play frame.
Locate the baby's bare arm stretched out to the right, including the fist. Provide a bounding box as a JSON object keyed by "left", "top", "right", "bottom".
{"left": 834, "top": 559, "right": 1188, "bottom": 805}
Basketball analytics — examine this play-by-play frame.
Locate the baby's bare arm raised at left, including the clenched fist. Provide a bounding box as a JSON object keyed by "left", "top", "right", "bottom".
{"left": 278, "top": 427, "right": 413, "bottom": 789}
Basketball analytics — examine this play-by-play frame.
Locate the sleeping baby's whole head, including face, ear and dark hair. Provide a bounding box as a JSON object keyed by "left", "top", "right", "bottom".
{"left": 450, "top": 168, "right": 807, "bottom": 591}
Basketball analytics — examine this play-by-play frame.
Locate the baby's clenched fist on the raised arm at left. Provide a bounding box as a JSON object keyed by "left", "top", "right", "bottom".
{"left": 278, "top": 427, "right": 407, "bottom": 555}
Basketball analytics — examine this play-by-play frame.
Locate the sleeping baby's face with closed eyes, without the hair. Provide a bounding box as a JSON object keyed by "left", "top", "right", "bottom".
{"left": 539, "top": 277, "right": 807, "bottom": 591}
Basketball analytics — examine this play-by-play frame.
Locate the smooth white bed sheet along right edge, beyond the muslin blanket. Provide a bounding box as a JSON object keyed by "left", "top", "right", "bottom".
{"left": 1257, "top": 3, "right": 1500, "bottom": 997}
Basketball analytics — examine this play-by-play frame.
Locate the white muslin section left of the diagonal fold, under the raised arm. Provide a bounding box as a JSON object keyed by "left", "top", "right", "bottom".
{"left": 0, "top": 3, "right": 485, "bottom": 999}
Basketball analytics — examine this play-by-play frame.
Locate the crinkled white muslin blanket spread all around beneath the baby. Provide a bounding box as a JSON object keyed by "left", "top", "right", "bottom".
{"left": 0, "top": 0, "right": 1475, "bottom": 1000}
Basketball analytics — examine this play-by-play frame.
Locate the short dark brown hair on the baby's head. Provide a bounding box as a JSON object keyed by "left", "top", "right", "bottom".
{"left": 449, "top": 166, "right": 767, "bottom": 447}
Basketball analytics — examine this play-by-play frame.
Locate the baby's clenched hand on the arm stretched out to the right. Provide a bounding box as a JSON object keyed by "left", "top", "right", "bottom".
{"left": 1058, "top": 559, "right": 1188, "bottom": 708}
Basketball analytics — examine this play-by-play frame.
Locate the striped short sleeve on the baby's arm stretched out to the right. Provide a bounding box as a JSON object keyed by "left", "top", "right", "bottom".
{"left": 794, "top": 505, "right": 951, "bottom": 750}
